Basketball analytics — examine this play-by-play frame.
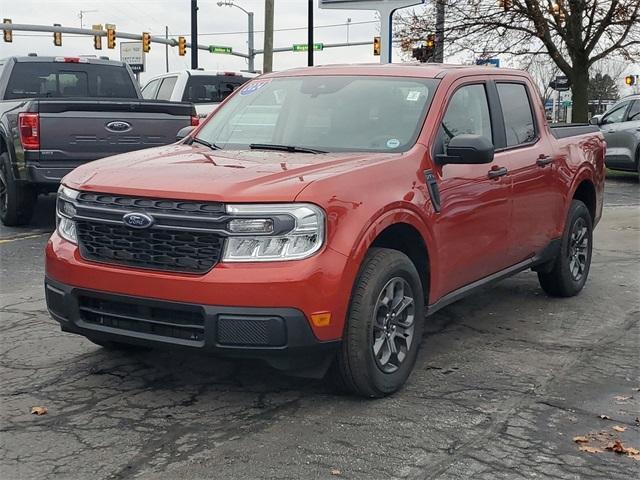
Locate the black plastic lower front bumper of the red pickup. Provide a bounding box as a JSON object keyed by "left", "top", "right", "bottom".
{"left": 45, "top": 278, "right": 340, "bottom": 376}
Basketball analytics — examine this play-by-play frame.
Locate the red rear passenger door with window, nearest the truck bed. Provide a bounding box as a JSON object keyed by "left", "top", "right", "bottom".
{"left": 495, "top": 79, "right": 564, "bottom": 264}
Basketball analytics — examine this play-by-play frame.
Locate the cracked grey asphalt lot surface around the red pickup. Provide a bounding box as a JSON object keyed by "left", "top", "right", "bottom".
{"left": 0, "top": 176, "right": 640, "bottom": 480}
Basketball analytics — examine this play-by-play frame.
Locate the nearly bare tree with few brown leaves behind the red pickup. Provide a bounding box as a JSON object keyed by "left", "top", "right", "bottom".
{"left": 396, "top": 0, "right": 640, "bottom": 122}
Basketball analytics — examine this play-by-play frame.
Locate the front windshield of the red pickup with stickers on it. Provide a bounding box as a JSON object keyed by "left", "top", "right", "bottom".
{"left": 198, "top": 76, "right": 437, "bottom": 152}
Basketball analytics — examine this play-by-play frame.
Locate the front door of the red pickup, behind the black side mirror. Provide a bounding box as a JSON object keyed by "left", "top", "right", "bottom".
{"left": 434, "top": 78, "right": 511, "bottom": 294}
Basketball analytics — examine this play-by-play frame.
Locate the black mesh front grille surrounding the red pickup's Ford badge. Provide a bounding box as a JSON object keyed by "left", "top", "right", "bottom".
{"left": 75, "top": 192, "right": 227, "bottom": 274}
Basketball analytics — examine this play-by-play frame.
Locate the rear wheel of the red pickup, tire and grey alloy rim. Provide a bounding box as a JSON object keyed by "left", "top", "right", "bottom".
{"left": 538, "top": 200, "right": 593, "bottom": 297}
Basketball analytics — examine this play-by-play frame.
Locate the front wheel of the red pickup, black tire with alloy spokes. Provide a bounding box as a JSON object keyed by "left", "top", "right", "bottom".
{"left": 334, "top": 248, "right": 424, "bottom": 398}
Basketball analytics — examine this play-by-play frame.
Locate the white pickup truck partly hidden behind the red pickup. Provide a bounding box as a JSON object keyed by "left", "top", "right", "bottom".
{"left": 142, "top": 70, "right": 257, "bottom": 117}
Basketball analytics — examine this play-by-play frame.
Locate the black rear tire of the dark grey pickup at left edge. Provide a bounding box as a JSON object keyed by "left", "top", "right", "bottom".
{"left": 0, "top": 152, "right": 37, "bottom": 227}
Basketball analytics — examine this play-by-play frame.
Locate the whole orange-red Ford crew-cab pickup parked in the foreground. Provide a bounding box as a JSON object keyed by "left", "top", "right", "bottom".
{"left": 45, "top": 64, "right": 605, "bottom": 397}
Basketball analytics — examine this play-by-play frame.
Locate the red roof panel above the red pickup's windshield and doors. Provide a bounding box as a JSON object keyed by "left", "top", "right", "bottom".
{"left": 263, "top": 63, "right": 526, "bottom": 78}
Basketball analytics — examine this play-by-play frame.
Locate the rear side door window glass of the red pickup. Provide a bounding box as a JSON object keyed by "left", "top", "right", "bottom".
{"left": 496, "top": 83, "right": 536, "bottom": 147}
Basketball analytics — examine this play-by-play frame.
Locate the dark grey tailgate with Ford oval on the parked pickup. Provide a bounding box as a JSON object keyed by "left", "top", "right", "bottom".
{"left": 38, "top": 99, "right": 195, "bottom": 166}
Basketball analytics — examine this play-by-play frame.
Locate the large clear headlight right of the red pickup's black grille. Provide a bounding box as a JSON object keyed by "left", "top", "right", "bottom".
{"left": 222, "top": 203, "right": 325, "bottom": 262}
